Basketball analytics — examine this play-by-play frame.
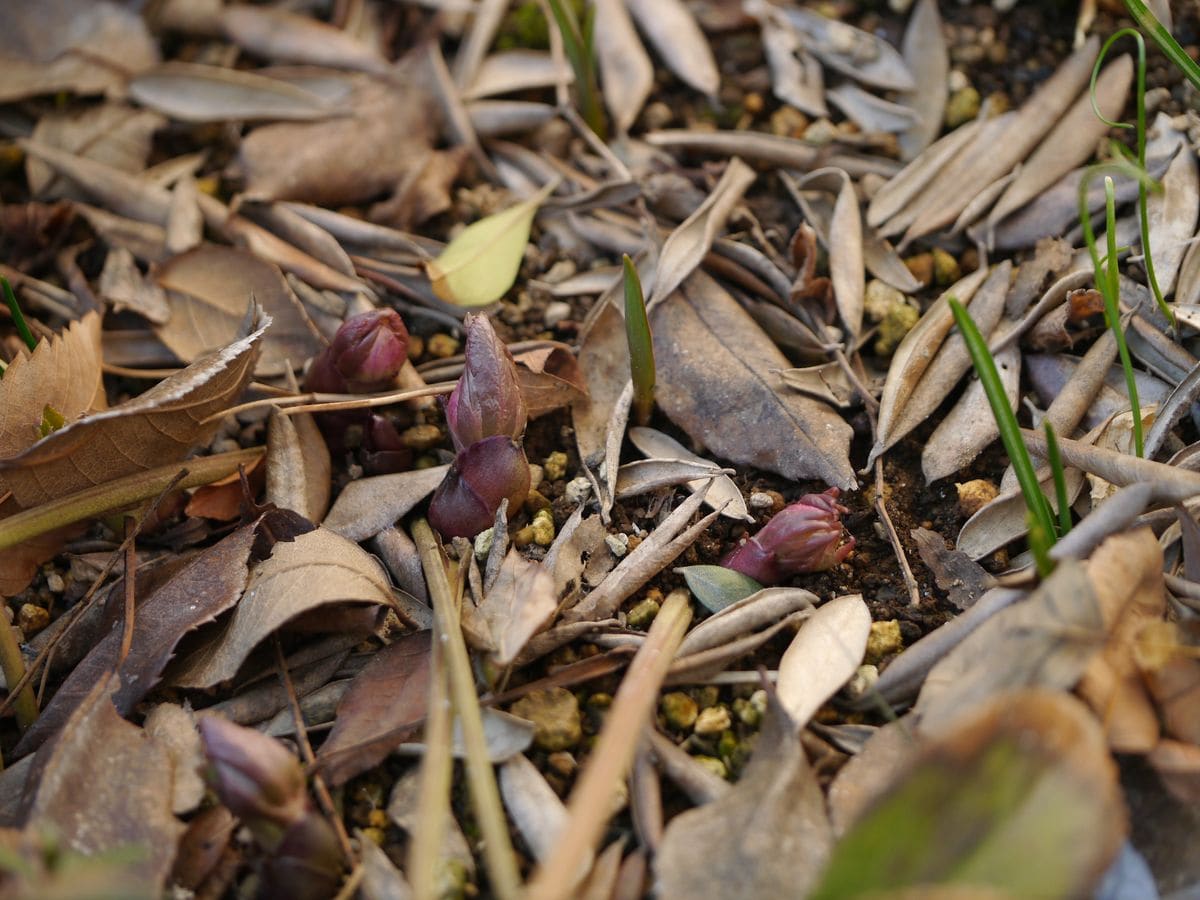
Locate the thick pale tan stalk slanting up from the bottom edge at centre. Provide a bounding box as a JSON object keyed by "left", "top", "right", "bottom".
{"left": 526, "top": 589, "right": 691, "bottom": 900}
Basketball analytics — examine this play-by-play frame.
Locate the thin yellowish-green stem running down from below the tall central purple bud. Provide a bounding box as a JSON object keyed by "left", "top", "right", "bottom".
{"left": 413, "top": 518, "right": 521, "bottom": 900}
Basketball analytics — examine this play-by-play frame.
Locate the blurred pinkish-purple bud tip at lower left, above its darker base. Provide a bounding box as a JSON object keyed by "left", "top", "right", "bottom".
{"left": 199, "top": 715, "right": 308, "bottom": 850}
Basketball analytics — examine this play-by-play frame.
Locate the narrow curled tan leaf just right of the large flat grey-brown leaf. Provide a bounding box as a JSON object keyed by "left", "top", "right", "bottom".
{"left": 868, "top": 265, "right": 988, "bottom": 464}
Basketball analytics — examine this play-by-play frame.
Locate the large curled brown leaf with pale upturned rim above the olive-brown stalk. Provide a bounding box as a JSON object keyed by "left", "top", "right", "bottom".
{"left": 0, "top": 308, "right": 270, "bottom": 509}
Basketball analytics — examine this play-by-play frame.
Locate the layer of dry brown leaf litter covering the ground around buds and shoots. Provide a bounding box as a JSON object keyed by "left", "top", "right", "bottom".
{"left": 0, "top": 0, "right": 1200, "bottom": 898}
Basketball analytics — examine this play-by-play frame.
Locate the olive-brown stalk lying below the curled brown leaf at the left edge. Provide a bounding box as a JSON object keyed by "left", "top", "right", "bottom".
{"left": 0, "top": 446, "right": 266, "bottom": 550}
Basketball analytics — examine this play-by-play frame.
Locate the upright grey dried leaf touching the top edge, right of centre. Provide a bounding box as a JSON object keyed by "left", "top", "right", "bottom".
{"left": 899, "top": 0, "right": 950, "bottom": 160}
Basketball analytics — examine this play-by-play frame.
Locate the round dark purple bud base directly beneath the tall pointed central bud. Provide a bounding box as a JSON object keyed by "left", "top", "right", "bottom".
{"left": 430, "top": 434, "right": 529, "bottom": 538}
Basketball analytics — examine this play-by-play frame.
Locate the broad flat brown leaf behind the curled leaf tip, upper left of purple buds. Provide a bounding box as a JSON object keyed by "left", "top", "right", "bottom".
{"left": 155, "top": 244, "right": 322, "bottom": 376}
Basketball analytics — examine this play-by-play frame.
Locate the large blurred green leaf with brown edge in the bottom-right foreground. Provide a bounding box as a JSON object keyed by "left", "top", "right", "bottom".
{"left": 809, "top": 690, "right": 1128, "bottom": 900}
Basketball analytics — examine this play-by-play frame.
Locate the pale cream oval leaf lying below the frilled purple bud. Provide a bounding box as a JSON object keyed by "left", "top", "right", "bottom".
{"left": 775, "top": 594, "right": 871, "bottom": 728}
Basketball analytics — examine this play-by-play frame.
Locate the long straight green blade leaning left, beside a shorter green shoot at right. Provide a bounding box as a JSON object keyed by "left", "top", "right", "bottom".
{"left": 949, "top": 296, "right": 1055, "bottom": 577}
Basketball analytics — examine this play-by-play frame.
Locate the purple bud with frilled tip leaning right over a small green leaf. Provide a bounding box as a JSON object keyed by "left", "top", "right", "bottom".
{"left": 721, "top": 487, "right": 854, "bottom": 584}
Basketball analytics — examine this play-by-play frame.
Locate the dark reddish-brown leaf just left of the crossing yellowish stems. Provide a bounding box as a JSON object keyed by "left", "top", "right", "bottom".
{"left": 319, "top": 631, "right": 431, "bottom": 785}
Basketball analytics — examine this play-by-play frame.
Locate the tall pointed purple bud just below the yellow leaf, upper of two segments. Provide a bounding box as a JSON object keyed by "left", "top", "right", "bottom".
{"left": 445, "top": 316, "right": 528, "bottom": 451}
